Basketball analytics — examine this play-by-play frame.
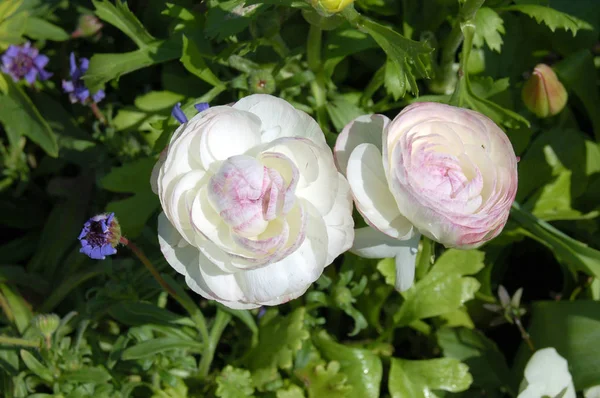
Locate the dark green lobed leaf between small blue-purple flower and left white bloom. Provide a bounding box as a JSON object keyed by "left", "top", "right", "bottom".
{"left": 101, "top": 158, "right": 159, "bottom": 237}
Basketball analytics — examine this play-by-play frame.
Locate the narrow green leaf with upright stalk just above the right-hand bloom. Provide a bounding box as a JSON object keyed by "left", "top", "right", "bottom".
{"left": 451, "top": 24, "right": 529, "bottom": 128}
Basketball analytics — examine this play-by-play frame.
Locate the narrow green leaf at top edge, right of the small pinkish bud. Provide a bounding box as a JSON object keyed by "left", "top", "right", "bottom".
{"left": 92, "top": 0, "right": 156, "bottom": 48}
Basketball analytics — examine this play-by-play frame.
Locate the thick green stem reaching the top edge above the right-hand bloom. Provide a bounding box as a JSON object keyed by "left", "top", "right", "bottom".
{"left": 431, "top": 0, "right": 485, "bottom": 94}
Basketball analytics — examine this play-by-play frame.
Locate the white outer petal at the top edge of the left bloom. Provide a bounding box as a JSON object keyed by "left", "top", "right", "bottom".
{"left": 233, "top": 94, "right": 327, "bottom": 146}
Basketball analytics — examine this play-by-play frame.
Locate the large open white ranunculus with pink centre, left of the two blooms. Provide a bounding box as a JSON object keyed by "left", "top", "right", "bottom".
{"left": 152, "top": 94, "right": 354, "bottom": 308}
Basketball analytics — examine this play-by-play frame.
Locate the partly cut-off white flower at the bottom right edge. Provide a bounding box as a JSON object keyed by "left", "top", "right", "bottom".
{"left": 517, "top": 347, "right": 575, "bottom": 398}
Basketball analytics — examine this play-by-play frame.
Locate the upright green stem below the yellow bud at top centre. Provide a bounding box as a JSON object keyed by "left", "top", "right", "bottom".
{"left": 306, "top": 25, "right": 327, "bottom": 129}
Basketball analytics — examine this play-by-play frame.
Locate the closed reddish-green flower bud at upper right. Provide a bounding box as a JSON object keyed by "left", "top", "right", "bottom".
{"left": 521, "top": 64, "right": 568, "bottom": 118}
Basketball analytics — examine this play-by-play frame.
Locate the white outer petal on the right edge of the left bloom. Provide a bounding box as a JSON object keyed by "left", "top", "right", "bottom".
{"left": 323, "top": 173, "right": 354, "bottom": 265}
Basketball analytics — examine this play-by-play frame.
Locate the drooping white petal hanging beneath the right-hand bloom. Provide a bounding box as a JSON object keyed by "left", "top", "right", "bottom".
{"left": 350, "top": 227, "right": 421, "bottom": 292}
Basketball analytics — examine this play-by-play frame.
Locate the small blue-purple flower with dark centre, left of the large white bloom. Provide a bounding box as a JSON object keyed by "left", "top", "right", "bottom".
{"left": 78, "top": 213, "right": 121, "bottom": 260}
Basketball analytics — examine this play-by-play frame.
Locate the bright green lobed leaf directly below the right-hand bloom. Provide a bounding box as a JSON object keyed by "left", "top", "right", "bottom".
{"left": 394, "top": 249, "right": 484, "bottom": 326}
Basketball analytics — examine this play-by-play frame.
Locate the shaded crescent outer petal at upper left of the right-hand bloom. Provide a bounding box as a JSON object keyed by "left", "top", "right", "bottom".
{"left": 333, "top": 115, "right": 390, "bottom": 175}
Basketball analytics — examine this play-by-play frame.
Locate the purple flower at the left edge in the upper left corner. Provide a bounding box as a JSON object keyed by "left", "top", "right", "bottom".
{"left": 2, "top": 42, "right": 52, "bottom": 84}
